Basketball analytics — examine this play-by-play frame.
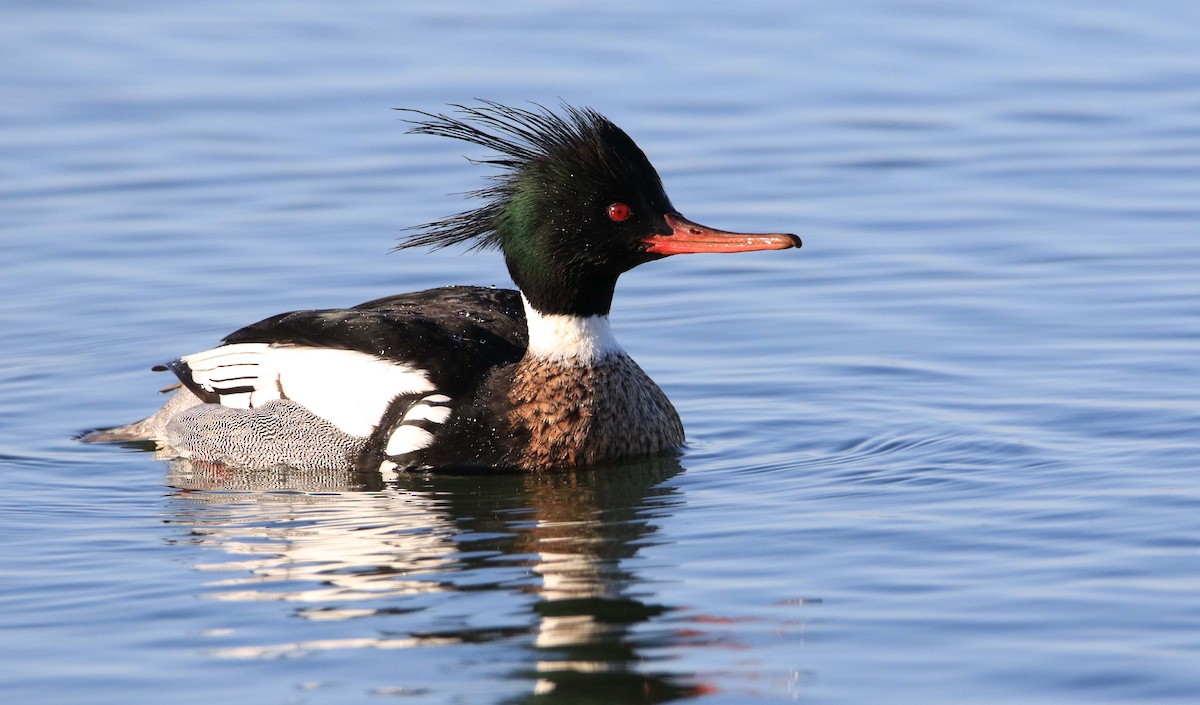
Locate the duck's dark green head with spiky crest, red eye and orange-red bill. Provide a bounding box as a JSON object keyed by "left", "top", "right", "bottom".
{"left": 398, "top": 102, "right": 800, "bottom": 317}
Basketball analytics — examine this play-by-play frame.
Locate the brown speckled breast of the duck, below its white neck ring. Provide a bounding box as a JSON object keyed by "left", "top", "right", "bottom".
{"left": 509, "top": 355, "right": 684, "bottom": 470}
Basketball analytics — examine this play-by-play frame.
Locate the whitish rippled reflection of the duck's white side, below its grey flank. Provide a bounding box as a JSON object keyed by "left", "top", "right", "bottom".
{"left": 170, "top": 460, "right": 457, "bottom": 619}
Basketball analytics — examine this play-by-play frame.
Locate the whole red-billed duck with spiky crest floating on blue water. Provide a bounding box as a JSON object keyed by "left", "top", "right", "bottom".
{"left": 85, "top": 101, "right": 802, "bottom": 472}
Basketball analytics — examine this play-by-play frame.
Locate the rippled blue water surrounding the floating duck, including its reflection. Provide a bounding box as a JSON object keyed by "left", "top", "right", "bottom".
{"left": 0, "top": 0, "right": 1200, "bottom": 705}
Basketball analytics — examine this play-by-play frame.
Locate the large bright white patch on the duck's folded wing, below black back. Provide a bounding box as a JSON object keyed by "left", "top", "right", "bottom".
{"left": 182, "top": 343, "right": 433, "bottom": 438}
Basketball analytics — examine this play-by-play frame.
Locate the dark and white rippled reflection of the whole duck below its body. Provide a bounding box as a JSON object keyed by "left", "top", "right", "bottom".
{"left": 162, "top": 458, "right": 708, "bottom": 704}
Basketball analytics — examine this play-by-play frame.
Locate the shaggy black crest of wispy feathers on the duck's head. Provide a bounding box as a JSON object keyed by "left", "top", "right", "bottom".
{"left": 395, "top": 101, "right": 661, "bottom": 249}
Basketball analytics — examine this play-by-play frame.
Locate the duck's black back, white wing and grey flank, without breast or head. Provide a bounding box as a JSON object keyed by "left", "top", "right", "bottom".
{"left": 152, "top": 287, "right": 528, "bottom": 469}
